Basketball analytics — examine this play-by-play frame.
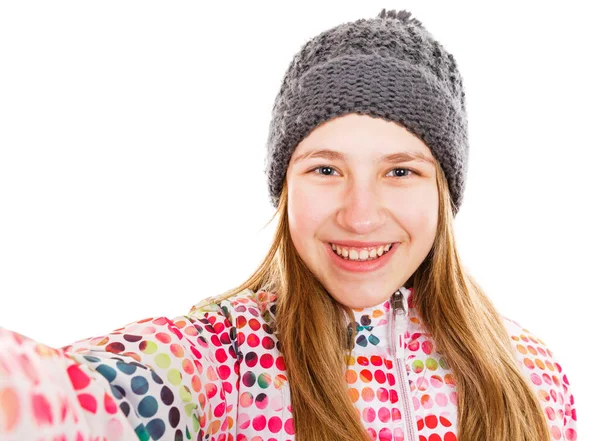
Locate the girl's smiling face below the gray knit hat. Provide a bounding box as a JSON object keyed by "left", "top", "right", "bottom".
{"left": 286, "top": 114, "right": 439, "bottom": 308}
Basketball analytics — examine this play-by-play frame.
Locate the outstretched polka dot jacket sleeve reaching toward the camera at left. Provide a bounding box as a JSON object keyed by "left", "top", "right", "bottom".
{"left": 0, "top": 302, "right": 239, "bottom": 441}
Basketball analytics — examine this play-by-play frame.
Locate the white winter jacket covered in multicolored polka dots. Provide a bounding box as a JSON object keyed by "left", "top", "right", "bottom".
{"left": 0, "top": 287, "right": 577, "bottom": 441}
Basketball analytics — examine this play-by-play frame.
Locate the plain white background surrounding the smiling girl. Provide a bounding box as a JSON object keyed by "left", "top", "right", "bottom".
{"left": 0, "top": 0, "right": 600, "bottom": 440}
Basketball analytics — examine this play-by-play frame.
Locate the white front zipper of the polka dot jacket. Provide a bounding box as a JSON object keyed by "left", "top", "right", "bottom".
{"left": 391, "top": 290, "right": 417, "bottom": 441}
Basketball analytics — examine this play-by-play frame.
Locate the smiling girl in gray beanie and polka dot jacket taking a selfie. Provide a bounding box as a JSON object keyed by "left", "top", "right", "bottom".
{"left": 0, "top": 9, "right": 577, "bottom": 441}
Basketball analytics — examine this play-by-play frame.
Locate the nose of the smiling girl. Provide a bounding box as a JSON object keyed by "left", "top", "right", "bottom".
{"left": 337, "top": 181, "right": 384, "bottom": 235}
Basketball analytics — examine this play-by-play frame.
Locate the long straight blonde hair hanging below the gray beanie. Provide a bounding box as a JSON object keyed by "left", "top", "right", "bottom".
{"left": 205, "top": 156, "right": 550, "bottom": 441}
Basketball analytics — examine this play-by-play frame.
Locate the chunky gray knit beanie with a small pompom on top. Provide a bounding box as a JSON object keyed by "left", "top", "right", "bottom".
{"left": 264, "top": 9, "right": 469, "bottom": 216}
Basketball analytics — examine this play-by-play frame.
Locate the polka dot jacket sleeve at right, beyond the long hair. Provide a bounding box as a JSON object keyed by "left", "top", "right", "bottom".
{"left": 504, "top": 317, "right": 577, "bottom": 441}
